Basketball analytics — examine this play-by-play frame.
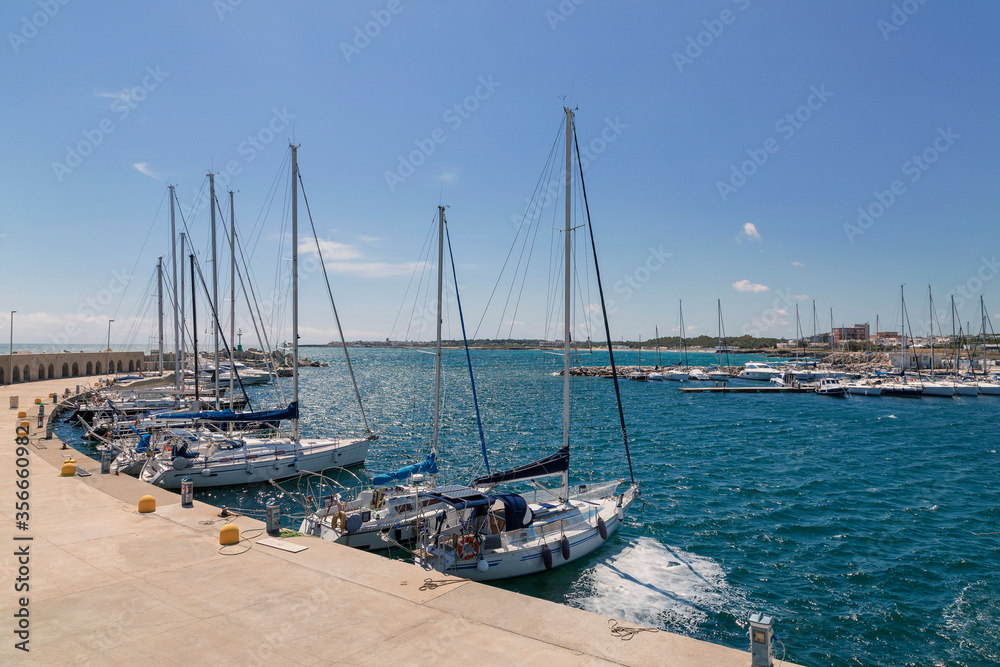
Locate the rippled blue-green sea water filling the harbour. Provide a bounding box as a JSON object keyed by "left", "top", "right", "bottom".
{"left": 60, "top": 348, "right": 1000, "bottom": 666}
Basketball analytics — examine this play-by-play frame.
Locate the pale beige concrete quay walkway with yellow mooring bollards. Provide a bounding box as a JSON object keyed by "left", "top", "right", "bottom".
{"left": 0, "top": 380, "right": 787, "bottom": 667}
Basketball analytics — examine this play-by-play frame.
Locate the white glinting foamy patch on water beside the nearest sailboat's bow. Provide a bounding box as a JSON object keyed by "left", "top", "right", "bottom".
{"left": 567, "top": 537, "right": 739, "bottom": 635}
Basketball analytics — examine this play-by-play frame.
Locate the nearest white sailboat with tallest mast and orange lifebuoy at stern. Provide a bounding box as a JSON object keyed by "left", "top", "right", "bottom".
{"left": 414, "top": 108, "right": 639, "bottom": 581}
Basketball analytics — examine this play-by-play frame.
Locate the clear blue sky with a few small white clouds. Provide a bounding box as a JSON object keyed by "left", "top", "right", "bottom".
{"left": 0, "top": 0, "right": 1000, "bottom": 345}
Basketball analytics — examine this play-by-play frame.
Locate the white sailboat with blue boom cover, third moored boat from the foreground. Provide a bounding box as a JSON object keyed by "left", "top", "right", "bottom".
{"left": 139, "top": 145, "right": 376, "bottom": 489}
